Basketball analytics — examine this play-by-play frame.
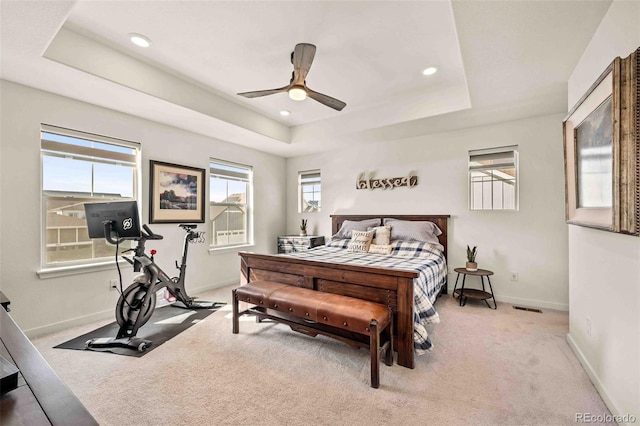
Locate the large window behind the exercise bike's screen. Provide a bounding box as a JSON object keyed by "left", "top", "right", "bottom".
{"left": 40, "top": 124, "right": 140, "bottom": 267}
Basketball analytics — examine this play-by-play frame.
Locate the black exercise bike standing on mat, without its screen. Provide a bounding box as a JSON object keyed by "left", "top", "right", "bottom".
{"left": 85, "top": 222, "right": 224, "bottom": 352}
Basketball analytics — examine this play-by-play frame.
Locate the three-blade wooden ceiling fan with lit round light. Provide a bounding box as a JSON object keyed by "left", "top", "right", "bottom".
{"left": 238, "top": 43, "right": 347, "bottom": 111}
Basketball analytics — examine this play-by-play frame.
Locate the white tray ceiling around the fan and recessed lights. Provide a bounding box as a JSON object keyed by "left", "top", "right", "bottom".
{"left": 0, "top": 0, "right": 610, "bottom": 157}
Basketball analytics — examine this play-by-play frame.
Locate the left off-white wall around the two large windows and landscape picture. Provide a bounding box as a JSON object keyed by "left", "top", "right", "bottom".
{"left": 0, "top": 81, "right": 285, "bottom": 336}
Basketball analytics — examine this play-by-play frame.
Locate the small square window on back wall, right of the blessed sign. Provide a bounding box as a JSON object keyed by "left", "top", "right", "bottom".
{"left": 469, "top": 146, "right": 518, "bottom": 210}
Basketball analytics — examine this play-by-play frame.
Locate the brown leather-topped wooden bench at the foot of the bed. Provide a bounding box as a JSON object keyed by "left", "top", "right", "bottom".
{"left": 233, "top": 281, "right": 393, "bottom": 388}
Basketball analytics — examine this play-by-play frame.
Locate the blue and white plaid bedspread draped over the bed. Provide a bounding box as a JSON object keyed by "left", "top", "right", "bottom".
{"left": 281, "top": 240, "right": 447, "bottom": 354}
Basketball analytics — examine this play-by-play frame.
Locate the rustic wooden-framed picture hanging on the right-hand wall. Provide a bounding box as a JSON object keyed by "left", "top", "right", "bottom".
{"left": 562, "top": 48, "right": 640, "bottom": 235}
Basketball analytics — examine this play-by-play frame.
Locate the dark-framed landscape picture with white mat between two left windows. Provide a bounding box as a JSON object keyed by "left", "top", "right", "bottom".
{"left": 149, "top": 160, "right": 205, "bottom": 223}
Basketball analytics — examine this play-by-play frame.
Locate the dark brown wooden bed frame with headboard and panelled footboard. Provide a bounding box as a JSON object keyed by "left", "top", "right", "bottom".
{"left": 239, "top": 215, "right": 449, "bottom": 368}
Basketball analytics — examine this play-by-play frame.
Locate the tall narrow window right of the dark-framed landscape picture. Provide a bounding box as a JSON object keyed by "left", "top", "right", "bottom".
{"left": 209, "top": 159, "right": 253, "bottom": 247}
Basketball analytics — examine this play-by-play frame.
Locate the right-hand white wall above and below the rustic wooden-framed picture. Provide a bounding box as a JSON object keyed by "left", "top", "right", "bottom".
{"left": 567, "top": 1, "right": 640, "bottom": 419}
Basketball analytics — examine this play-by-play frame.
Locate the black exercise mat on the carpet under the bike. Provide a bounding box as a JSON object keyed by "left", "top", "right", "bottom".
{"left": 54, "top": 303, "right": 225, "bottom": 357}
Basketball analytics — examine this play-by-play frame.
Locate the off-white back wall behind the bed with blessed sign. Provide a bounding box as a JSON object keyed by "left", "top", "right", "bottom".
{"left": 287, "top": 114, "right": 569, "bottom": 310}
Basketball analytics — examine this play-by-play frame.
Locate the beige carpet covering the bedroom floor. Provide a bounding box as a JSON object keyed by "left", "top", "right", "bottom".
{"left": 34, "top": 287, "right": 609, "bottom": 425}
